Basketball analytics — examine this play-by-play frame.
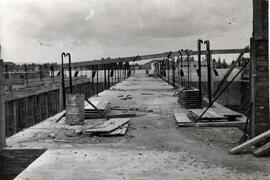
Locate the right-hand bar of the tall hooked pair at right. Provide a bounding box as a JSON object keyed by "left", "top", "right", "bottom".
{"left": 204, "top": 40, "right": 212, "bottom": 104}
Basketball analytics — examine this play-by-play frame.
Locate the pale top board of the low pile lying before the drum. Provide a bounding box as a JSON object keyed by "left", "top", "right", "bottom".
{"left": 85, "top": 118, "right": 130, "bottom": 134}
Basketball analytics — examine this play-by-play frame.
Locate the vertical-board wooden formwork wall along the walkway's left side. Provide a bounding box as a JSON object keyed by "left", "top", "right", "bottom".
{"left": 5, "top": 82, "right": 113, "bottom": 136}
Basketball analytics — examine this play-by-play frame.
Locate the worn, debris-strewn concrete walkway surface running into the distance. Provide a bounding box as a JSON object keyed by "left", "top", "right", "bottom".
{"left": 7, "top": 71, "right": 270, "bottom": 180}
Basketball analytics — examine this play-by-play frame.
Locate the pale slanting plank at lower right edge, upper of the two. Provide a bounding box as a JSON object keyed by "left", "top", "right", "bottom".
{"left": 230, "top": 130, "right": 270, "bottom": 154}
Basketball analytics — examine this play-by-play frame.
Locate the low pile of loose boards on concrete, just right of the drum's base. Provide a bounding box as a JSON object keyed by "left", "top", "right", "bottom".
{"left": 85, "top": 118, "right": 130, "bottom": 136}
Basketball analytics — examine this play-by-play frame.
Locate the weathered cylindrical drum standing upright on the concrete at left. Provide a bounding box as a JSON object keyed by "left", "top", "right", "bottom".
{"left": 66, "top": 94, "right": 85, "bottom": 125}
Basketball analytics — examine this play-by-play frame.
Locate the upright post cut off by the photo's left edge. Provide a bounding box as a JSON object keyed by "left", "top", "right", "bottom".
{"left": 0, "top": 57, "right": 6, "bottom": 150}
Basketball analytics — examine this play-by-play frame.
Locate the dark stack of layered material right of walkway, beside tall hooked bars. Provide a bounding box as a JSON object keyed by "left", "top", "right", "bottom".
{"left": 178, "top": 89, "right": 200, "bottom": 109}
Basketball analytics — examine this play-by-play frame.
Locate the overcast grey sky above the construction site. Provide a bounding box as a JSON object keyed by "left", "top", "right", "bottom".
{"left": 0, "top": 0, "right": 252, "bottom": 63}
